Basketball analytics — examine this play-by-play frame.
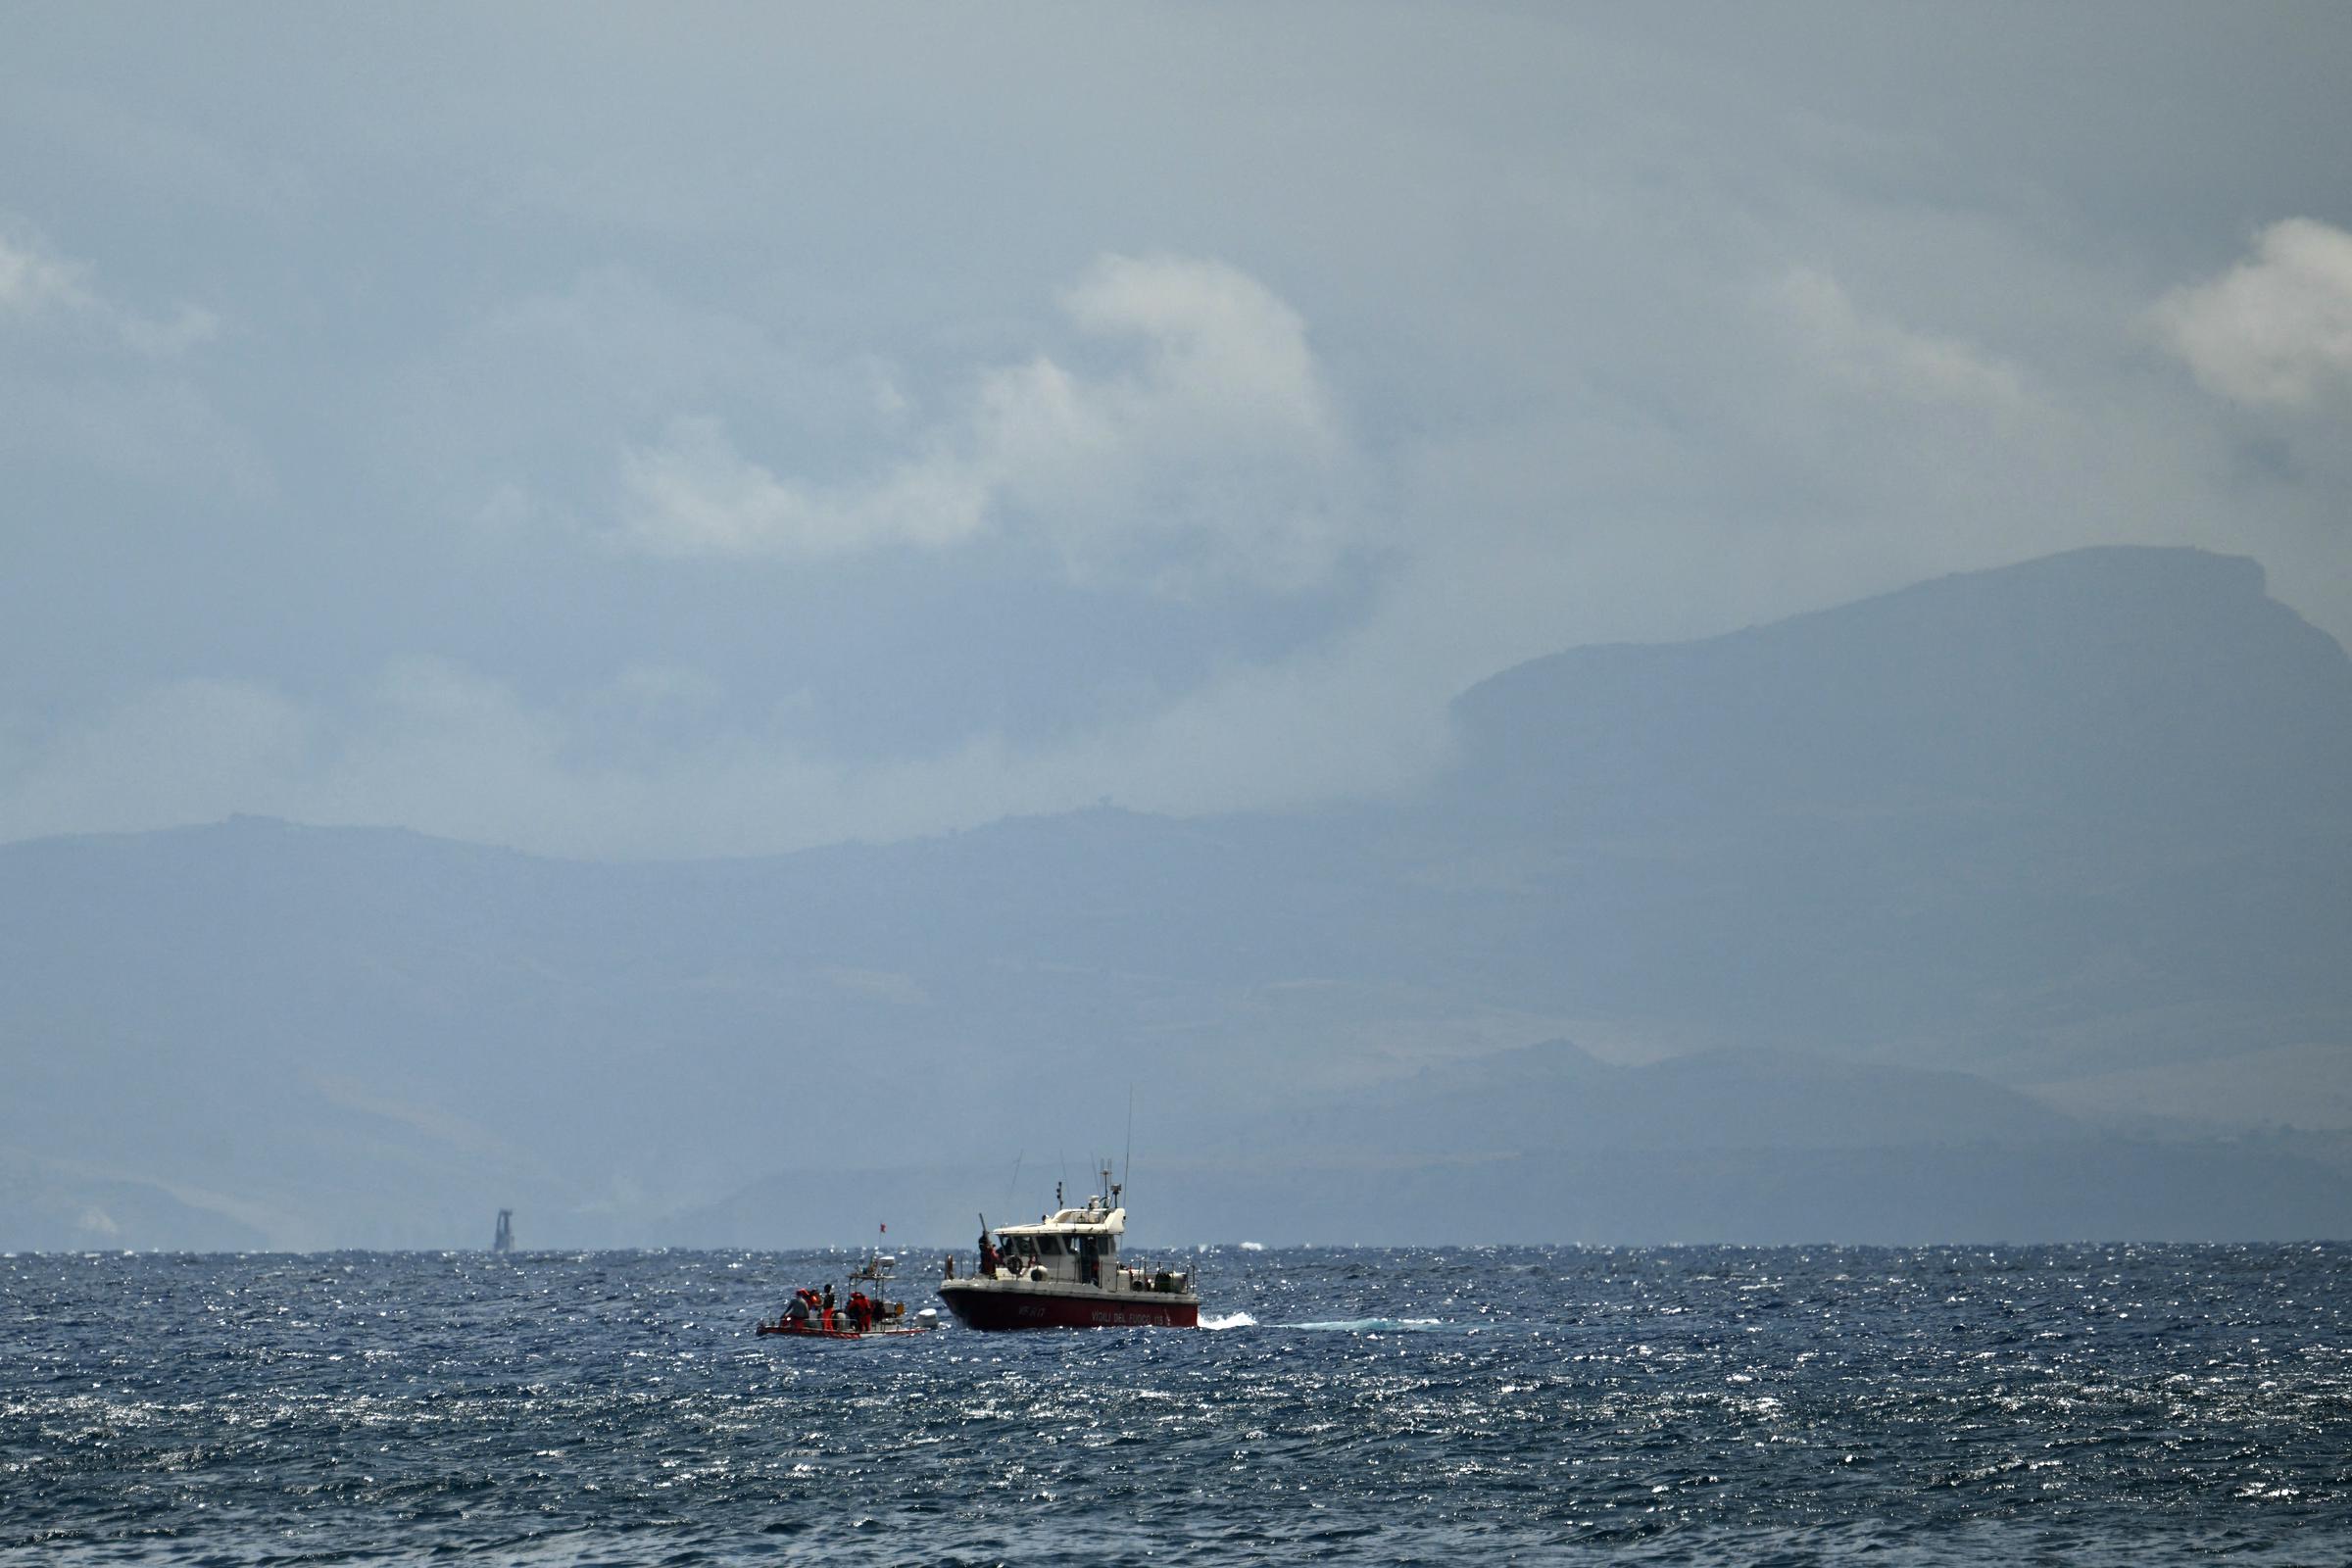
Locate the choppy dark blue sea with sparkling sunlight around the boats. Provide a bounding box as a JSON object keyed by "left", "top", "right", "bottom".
{"left": 0, "top": 1246, "right": 2352, "bottom": 1563}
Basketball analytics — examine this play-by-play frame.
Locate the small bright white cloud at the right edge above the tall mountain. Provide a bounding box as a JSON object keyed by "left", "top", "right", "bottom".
{"left": 2154, "top": 219, "right": 2352, "bottom": 409}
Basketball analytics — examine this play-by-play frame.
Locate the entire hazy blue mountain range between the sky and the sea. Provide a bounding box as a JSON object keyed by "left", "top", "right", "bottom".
{"left": 0, "top": 550, "right": 2352, "bottom": 1246}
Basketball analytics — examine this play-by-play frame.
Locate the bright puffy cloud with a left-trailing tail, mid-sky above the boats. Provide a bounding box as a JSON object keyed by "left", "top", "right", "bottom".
{"left": 616, "top": 256, "right": 1352, "bottom": 595}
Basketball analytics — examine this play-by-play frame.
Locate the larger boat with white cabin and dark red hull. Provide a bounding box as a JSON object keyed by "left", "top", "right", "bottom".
{"left": 939, "top": 1168, "right": 1200, "bottom": 1328}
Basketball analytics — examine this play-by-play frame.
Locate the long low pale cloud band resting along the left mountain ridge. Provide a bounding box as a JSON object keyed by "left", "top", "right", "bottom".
{"left": 0, "top": 644, "right": 1445, "bottom": 858}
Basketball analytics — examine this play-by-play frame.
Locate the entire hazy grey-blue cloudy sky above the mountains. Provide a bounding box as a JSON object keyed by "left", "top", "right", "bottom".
{"left": 0, "top": 2, "right": 2352, "bottom": 858}
